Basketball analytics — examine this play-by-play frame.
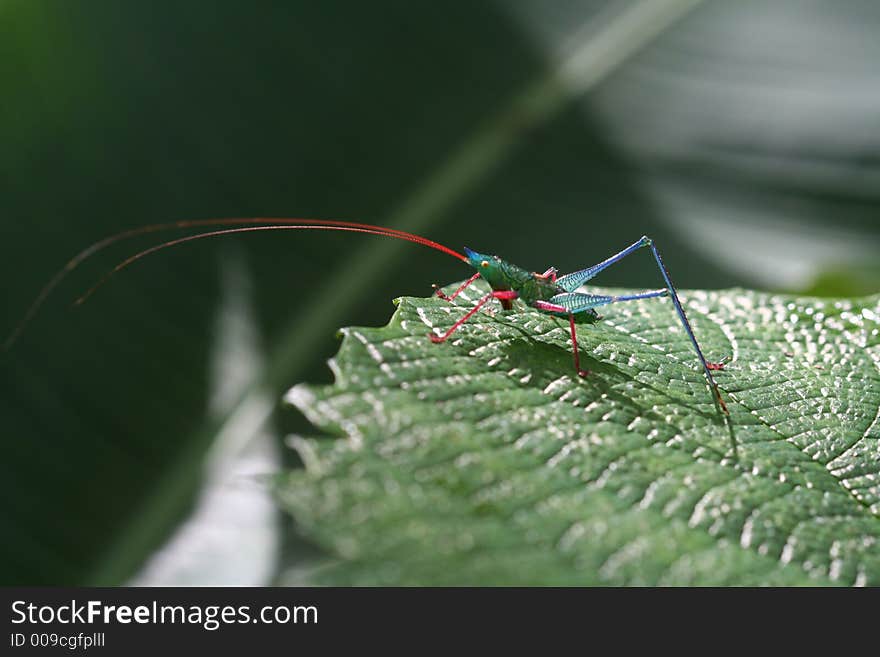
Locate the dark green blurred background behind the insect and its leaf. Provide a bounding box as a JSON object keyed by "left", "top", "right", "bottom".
{"left": 0, "top": 0, "right": 880, "bottom": 584}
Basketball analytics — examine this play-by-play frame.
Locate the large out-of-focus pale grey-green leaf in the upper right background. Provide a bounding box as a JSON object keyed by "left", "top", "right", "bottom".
{"left": 514, "top": 0, "right": 880, "bottom": 296}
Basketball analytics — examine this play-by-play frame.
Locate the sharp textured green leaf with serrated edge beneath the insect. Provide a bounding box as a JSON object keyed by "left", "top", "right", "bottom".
{"left": 278, "top": 286, "right": 880, "bottom": 585}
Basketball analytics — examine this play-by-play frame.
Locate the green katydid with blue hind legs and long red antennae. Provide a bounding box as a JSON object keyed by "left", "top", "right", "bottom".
{"left": 4, "top": 218, "right": 728, "bottom": 415}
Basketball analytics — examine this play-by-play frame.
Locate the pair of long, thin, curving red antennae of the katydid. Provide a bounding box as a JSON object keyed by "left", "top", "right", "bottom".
{"left": 3, "top": 218, "right": 468, "bottom": 350}
